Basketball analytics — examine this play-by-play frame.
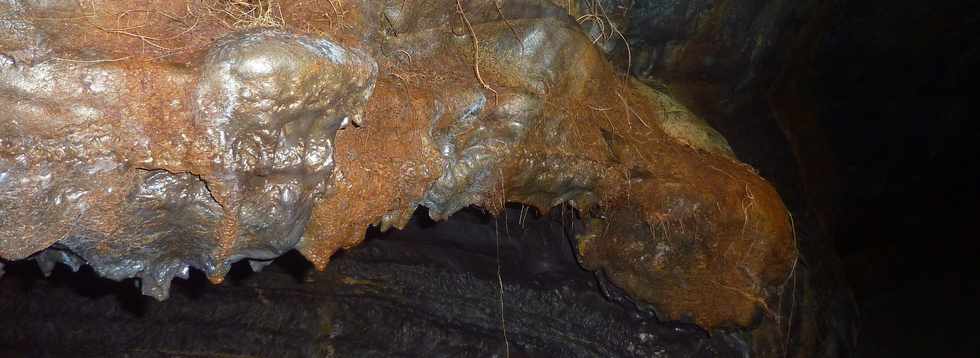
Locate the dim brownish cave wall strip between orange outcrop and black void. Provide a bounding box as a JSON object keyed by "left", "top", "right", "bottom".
{"left": 617, "top": 0, "right": 859, "bottom": 356}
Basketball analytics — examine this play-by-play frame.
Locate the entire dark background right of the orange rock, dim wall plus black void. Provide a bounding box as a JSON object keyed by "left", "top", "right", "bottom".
{"left": 618, "top": 0, "right": 980, "bottom": 356}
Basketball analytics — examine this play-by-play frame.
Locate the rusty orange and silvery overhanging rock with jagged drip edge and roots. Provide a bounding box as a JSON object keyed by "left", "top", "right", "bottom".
{"left": 0, "top": 0, "right": 796, "bottom": 328}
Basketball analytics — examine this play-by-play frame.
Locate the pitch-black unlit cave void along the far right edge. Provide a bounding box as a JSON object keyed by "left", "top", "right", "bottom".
{"left": 817, "top": 1, "right": 980, "bottom": 357}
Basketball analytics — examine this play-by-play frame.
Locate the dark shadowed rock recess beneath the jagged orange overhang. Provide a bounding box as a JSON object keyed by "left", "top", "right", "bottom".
{"left": 0, "top": 206, "right": 748, "bottom": 357}
